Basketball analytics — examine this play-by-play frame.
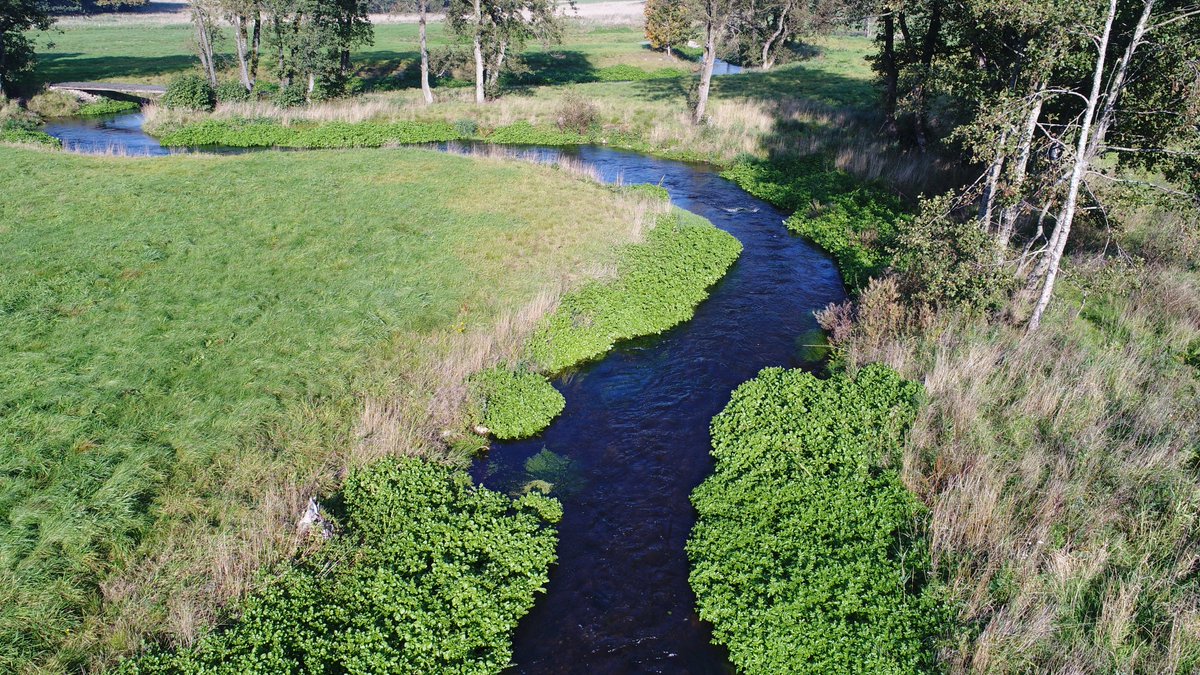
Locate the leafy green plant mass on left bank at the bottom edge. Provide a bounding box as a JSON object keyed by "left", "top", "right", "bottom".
{"left": 121, "top": 459, "right": 563, "bottom": 675}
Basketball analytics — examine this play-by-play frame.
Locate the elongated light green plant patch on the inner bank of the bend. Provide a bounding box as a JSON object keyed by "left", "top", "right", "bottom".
{"left": 527, "top": 211, "right": 742, "bottom": 372}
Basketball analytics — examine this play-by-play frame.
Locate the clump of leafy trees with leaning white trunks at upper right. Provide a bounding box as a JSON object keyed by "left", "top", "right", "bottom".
{"left": 874, "top": 0, "right": 1200, "bottom": 329}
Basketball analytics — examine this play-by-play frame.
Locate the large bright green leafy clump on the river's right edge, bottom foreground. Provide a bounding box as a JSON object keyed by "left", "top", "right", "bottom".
{"left": 688, "top": 365, "right": 948, "bottom": 675}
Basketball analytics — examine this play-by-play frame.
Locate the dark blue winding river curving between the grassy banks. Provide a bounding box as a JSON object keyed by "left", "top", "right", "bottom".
{"left": 47, "top": 114, "right": 845, "bottom": 674}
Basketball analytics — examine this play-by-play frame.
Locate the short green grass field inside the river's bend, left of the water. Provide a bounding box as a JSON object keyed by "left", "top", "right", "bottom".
{"left": 0, "top": 148, "right": 637, "bottom": 673}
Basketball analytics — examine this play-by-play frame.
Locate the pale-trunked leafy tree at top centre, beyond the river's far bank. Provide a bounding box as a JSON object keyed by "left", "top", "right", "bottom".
{"left": 446, "top": 0, "right": 574, "bottom": 103}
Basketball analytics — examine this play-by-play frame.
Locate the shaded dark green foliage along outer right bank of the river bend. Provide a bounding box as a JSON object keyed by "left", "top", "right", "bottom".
{"left": 721, "top": 156, "right": 908, "bottom": 291}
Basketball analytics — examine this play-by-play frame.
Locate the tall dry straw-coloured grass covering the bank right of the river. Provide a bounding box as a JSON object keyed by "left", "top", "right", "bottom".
{"left": 822, "top": 251, "right": 1200, "bottom": 673}
